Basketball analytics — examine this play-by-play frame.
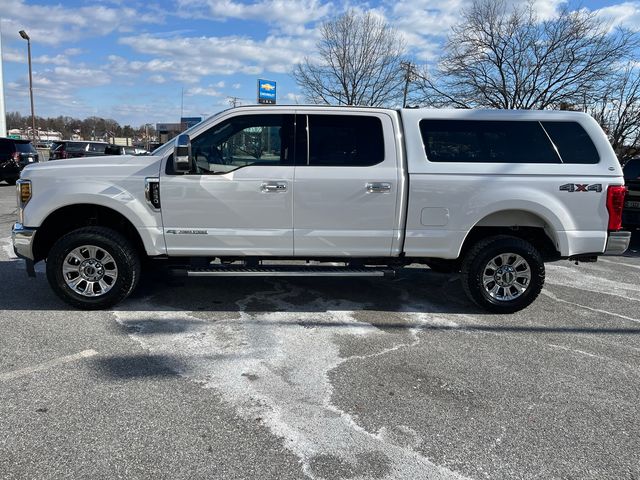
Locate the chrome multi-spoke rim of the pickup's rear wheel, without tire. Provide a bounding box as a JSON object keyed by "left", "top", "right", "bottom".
{"left": 482, "top": 253, "right": 531, "bottom": 302}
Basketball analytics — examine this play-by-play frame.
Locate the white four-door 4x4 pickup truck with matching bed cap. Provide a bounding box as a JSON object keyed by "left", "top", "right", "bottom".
{"left": 13, "top": 106, "right": 630, "bottom": 312}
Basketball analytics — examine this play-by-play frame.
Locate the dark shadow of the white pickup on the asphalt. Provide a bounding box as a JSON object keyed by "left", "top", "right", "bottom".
{"left": 0, "top": 260, "right": 640, "bottom": 335}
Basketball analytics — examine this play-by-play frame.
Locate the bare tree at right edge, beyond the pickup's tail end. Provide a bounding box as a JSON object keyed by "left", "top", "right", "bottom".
{"left": 583, "top": 63, "right": 640, "bottom": 163}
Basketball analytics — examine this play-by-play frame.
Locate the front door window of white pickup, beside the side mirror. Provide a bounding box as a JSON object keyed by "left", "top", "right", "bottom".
{"left": 191, "top": 114, "right": 294, "bottom": 174}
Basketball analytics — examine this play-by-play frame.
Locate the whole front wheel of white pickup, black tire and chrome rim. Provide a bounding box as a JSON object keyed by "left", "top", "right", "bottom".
{"left": 47, "top": 227, "right": 140, "bottom": 310}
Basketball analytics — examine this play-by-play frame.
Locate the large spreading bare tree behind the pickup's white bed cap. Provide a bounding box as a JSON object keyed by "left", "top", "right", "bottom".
{"left": 419, "top": 0, "right": 637, "bottom": 109}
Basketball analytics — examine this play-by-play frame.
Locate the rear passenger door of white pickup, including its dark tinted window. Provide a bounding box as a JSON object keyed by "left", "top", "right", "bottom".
{"left": 293, "top": 111, "right": 401, "bottom": 257}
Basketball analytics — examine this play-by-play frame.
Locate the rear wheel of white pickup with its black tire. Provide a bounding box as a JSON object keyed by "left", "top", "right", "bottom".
{"left": 461, "top": 235, "right": 545, "bottom": 313}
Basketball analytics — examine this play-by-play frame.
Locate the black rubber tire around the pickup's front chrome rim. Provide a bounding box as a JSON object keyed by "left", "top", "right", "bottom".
{"left": 47, "top": 227, "right": 141, "bottom": 310}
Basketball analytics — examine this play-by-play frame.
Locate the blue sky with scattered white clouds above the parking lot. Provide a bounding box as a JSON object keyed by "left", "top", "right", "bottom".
{"left": 0, "top": 0, "right": 640, "bottom": 126}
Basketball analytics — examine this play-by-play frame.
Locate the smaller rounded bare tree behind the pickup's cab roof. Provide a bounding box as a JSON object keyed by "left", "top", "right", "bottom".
{"left": 293, "top": 10, "right": 405, "bottom": 106}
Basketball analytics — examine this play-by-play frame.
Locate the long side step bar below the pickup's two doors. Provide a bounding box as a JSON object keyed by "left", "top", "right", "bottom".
{"left": 171, "top": 265, "right": 396, "bottom": 277}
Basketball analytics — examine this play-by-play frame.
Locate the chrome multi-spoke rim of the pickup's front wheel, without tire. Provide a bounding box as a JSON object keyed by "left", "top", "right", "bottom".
{"left": 62, "top": 245, "right": 118, "bottom": 297}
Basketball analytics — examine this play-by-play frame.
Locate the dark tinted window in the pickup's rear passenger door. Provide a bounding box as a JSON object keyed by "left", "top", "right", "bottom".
{"left": 309, "top": 115, "right": 384, "bottom": 167}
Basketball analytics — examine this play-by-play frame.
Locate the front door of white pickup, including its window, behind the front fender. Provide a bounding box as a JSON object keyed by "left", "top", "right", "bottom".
{"left": 160, "top": 112, "right": 294, "bottom": 256}
